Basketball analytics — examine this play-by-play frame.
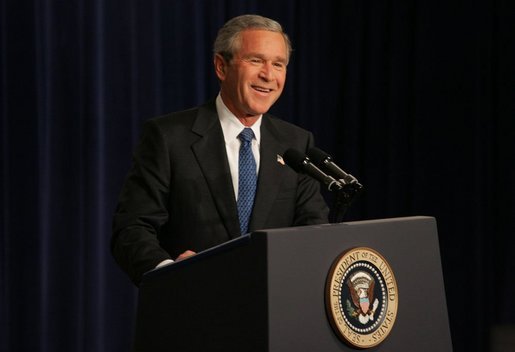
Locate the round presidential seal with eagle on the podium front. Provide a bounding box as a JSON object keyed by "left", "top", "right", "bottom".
{"left": 325, "top": 247, "right": 399, "bottom": 348}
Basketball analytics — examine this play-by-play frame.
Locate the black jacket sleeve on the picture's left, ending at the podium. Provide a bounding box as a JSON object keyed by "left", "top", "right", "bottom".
{"left": 111, "top": 120, "right": 171, "bottom": 285}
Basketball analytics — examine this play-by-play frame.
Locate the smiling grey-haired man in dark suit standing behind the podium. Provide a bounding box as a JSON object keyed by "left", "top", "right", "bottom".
{"left": 111, "top": 15, "right": 328, "bottom": 284}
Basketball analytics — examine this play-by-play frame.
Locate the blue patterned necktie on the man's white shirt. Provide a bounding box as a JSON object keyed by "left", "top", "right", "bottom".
{"left": 237, "top": 128, "right": 257, "bottom": 235}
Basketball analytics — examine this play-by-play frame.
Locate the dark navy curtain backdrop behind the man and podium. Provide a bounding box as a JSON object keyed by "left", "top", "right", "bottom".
{"left": 0, "top": 0, "right": 515, "bottom": 352}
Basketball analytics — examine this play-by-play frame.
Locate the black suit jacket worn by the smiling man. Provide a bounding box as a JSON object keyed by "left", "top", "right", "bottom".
{"left": 111, "top": 101, "right": 328, "bottom": 284}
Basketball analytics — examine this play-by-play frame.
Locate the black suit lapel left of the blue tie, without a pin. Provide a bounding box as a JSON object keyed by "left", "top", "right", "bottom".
{"left": 192, "top": 103, "right": 240, "bottom": 238}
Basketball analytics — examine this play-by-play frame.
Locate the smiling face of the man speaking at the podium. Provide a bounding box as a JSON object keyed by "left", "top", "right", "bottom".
{"left": 215, "top": 30, "right": 288, "bottom": 118}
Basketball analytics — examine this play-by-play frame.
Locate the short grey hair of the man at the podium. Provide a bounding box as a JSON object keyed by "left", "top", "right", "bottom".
{"left": 213, "top": 15, "right": 292, "bottom": 62}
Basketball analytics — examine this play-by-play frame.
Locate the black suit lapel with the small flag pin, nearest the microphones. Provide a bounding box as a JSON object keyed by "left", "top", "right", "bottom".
{"left": 249, "top": 115, "right": 286, "bottom": 231}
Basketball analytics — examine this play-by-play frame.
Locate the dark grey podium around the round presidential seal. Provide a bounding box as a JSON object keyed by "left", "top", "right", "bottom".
{"left": 134, "top": 217, "right": 452, "bottom": 352}
